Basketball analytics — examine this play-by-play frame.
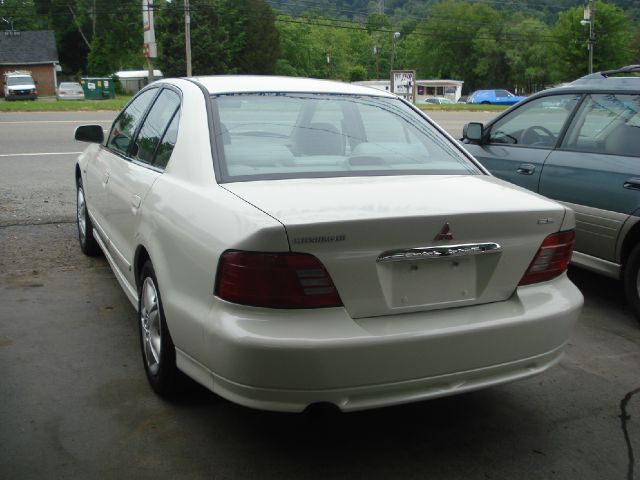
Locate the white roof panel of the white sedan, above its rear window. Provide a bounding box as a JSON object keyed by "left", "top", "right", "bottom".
{"left": 193, "top": 75, "right": 396, "bottom": 98}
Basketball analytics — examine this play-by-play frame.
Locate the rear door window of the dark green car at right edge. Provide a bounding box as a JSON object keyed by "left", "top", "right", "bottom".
{"left": 561, "top": 94, "right": 640, "bottom": 156}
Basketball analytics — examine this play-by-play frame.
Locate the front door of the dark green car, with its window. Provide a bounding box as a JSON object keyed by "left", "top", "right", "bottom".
{"left": 465, "top": 94, "right": 580, "bottom": 192}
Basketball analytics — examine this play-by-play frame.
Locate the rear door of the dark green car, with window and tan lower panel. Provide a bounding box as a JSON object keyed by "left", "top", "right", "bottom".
{"left": 540, "top": 93, "right": 640, "bottom": 262}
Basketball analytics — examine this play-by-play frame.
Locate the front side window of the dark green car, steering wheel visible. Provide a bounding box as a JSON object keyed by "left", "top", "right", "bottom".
{"left": 489, "top": 94, "right": 580, "bottom": 148}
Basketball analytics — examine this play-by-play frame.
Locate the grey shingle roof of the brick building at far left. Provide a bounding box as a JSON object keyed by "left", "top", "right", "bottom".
{"left": 0, "top": 30, "right": 58, "bottom": 65}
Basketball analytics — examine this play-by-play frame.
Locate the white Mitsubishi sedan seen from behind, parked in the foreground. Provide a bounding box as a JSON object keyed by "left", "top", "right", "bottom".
{"left": 75, "top": 76, "right": 583, "bottom": 412}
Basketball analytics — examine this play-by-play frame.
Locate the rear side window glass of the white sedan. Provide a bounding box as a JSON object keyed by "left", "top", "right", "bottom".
{"left": 133, "top": 89, "right": 180, "bottom": 167}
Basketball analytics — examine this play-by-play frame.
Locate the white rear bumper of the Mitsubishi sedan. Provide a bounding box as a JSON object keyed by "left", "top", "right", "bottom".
{"left": 172, "top": 275, "right": 583, "bottom": 412}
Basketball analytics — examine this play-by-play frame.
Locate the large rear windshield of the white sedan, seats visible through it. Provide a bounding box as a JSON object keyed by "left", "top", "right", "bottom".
{"left": 212, "top": 93, "right": 481, "bottom": 182}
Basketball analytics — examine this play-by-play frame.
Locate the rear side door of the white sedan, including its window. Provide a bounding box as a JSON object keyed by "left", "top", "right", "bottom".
{"left": 107, "top": 88, "right": 180, "bottom": 285}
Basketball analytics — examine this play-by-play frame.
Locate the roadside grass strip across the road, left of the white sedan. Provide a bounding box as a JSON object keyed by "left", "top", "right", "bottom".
{"left": 0, "top": 95, "right": 131, "bottom": 112}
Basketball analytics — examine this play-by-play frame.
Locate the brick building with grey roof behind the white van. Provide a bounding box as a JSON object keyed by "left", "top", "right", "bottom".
{"left": 0, "top": 30, "right": 60, "bottom": 95}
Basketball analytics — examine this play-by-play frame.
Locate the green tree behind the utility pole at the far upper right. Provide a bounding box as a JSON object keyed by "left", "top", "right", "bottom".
{"left": 553, "top": 1, "right": 637, "bottom": 81}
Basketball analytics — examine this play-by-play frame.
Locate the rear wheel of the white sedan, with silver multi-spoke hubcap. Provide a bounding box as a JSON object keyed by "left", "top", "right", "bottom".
{"left": 138, "top": 260, "right": 184, "bottom": 396}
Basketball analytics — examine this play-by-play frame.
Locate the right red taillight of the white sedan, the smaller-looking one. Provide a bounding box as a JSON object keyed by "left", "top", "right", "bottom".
{"left": 520, "top": 230, "right": 575, "bottom": 285}
